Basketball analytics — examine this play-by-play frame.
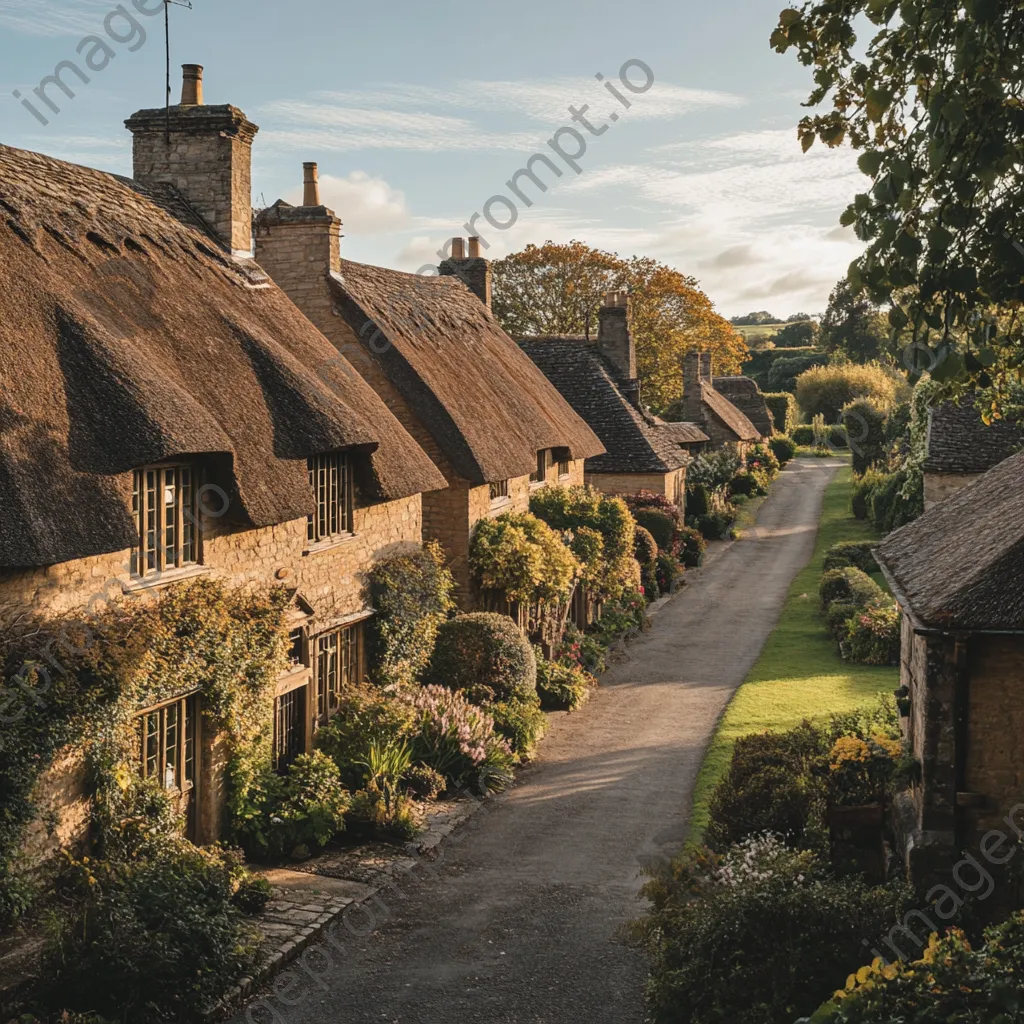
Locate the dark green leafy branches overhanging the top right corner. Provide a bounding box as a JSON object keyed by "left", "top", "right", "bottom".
{"left": 771, "top": 0, "right": 1024, "bottom": 401}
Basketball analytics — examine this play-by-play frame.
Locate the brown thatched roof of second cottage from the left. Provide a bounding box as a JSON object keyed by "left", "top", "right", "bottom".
{"left": 331, "top": 260, "right": 604, "bottom": 484}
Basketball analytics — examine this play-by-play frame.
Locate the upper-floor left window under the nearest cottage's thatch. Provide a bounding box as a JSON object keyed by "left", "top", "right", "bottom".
{"left": 131, "top": 464, "right": 199, "bottom": 578}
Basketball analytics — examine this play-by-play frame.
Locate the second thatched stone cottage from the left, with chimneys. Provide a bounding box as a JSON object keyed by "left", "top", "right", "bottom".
{"left": 256, "top": 174, "right": 603, "bottom": 608}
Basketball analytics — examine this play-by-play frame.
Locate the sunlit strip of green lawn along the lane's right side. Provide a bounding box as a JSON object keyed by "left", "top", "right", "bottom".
{"left": 689, "top": 466, "right": 899, "bottom": 842}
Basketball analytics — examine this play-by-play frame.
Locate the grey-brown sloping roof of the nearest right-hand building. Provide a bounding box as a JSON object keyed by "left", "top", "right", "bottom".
{"left": 877, "top": 455, "right": 1024, "bottom": 630}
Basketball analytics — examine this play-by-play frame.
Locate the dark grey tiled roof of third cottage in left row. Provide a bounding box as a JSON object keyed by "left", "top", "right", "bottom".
{"left": 519, "top": 338, "right": 692, "bottom": 473}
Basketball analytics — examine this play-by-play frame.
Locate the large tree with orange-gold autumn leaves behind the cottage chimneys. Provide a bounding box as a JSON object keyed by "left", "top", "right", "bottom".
{"left": 493, "top": 242, "right": 749, "bottom": 411}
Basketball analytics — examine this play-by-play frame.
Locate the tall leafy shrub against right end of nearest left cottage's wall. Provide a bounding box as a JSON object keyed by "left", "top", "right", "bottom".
{"left": 367, "top": 543, "right": 455, "bottom": 685}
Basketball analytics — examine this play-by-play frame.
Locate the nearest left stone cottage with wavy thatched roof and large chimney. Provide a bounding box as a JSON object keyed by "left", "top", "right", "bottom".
{"left": 0, "top": 68, "right": 444, "bottom": 842}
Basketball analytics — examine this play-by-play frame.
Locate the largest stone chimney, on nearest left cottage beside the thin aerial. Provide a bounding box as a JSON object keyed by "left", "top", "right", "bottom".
{"left": 125, "top": 65, "right": 259, "bottom": 256}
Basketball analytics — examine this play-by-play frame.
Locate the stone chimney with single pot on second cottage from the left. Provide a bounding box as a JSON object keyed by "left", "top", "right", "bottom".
{"left": 256, "top": 163, "right": 342, "bottom": 333}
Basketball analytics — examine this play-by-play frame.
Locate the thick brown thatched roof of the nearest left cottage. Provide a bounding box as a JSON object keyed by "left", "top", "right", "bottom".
{"left": 0, "top": 146, "right": 444, "bottom": 567}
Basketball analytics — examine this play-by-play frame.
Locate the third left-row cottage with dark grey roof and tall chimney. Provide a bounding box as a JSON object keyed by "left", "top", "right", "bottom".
{"left": 520, "top": 292, "right": 708, "bottom": 512}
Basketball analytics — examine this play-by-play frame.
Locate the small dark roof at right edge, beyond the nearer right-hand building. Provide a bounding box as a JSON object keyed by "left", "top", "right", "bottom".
{"left": 924, "top": 396, "right": 1024, "bottom": 473}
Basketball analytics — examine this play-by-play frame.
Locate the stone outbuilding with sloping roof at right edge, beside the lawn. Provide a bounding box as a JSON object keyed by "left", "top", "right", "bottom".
{"left": 877, "top": 455, "right": 1024, "bottom": 883}
